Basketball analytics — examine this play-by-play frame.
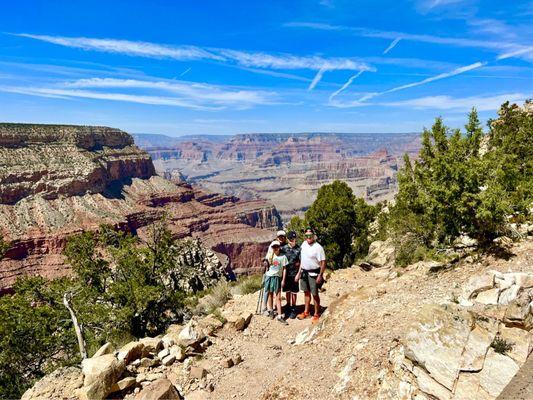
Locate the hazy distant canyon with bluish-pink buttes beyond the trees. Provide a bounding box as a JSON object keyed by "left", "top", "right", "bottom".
{"left": 133, "top": 133, "right": 420, "bottom": 222}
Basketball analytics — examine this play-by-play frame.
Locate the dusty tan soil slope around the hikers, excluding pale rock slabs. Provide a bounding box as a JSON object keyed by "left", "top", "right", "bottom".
{"left": 181, "top": 240, "right": 533, "bottom": 400}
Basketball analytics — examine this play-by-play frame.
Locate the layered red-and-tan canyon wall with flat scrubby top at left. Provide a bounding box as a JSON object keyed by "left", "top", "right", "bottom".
{"left": 0, "top": 123, "right": 281, "bottom": 290}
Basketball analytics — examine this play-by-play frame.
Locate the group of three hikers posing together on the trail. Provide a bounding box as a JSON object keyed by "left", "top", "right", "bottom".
{"left": 262, "top": 228, "right": 326, "bottom": 324}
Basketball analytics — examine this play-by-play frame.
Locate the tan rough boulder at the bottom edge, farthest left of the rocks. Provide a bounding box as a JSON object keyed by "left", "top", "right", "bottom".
{"left": 21, "top": 367, "right": 83, "bottom": 400}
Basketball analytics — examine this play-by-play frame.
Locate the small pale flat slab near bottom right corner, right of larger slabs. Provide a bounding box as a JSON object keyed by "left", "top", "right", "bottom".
{"left": 479, "top": 348, "right": 519, "bottom": 397}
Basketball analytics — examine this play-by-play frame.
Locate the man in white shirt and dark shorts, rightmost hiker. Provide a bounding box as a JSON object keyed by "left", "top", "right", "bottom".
{"left": 295, "top": 228, "right": 326, "bottom": 324}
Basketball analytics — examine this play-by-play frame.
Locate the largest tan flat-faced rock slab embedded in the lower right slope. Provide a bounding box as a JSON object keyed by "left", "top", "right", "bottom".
{"left": 404, "top": 304, "right": 473, "bottom": 390}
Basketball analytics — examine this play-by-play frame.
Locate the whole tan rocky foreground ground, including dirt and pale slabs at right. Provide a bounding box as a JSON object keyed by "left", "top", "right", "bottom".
{"left": 22, "top": 239, "right": 533, "bottom": 400}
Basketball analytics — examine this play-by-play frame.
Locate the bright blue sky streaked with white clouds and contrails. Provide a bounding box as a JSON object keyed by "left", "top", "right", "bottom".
{"left": 0, "top": 0, "right": 533, "bottom": 135}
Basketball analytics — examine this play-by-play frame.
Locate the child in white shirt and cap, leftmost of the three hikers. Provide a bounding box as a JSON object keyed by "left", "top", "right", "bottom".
{"left": 265, "top": 240, "right": 288, "bottom": 325}
